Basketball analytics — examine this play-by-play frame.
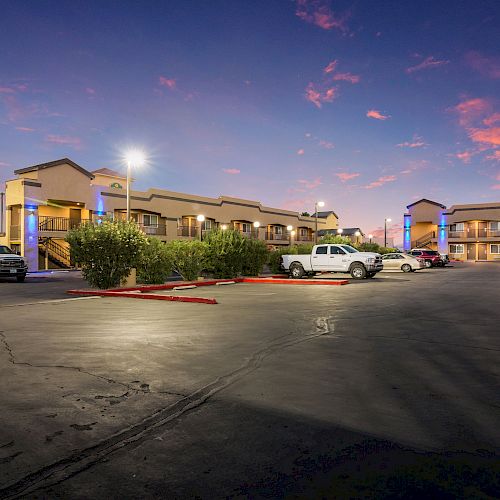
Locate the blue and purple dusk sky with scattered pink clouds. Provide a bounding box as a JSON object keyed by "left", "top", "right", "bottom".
{"left": 0, "top": 0, "right": 500, "bottom": 241}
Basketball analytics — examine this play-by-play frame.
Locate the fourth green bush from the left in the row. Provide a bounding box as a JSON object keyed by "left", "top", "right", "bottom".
{"left": 204, "top": 229, "right": 250, "bottom": 278}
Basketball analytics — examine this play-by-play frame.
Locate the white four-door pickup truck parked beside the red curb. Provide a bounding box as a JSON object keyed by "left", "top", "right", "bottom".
{"left": 281, "top": 244, "right": 384, "bottom": 280}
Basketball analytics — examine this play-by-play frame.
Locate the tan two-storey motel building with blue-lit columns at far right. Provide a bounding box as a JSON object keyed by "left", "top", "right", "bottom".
{"left": 403, "top": 199, "right": 500, "bottom": 261}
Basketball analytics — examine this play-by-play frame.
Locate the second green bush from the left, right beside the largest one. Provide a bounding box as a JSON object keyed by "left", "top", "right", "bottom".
{"left": 137, "top": 238, "right": 173, "bottom": 285}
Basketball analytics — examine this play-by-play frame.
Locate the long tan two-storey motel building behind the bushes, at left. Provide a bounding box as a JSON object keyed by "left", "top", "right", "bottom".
{"left": 0, "top": 158, "right": 338, "bottom": 271}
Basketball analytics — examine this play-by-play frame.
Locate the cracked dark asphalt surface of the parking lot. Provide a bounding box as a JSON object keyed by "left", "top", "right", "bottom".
{"left": 0, "top": 263, "right": 500, "bottom": 499}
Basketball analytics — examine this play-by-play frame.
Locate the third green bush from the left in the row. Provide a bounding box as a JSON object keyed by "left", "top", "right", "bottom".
{"left": 165, "top": 240, "right": 207, "bottom": 281}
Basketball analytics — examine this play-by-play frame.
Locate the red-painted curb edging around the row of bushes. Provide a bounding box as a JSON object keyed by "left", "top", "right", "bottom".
{"left": 67, "top": 276, "right": 349, "bottom": 304}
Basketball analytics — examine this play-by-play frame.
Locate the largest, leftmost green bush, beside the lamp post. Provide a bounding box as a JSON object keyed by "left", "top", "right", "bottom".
{"left": 66, "top": 220, "right": 146, "bottom": 289}
